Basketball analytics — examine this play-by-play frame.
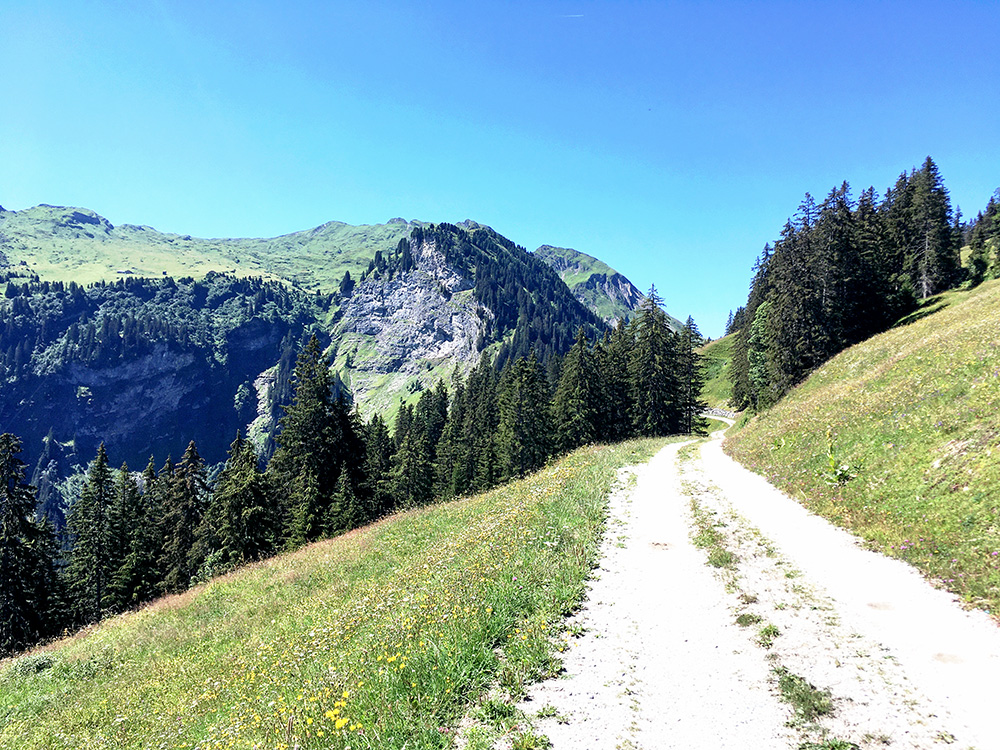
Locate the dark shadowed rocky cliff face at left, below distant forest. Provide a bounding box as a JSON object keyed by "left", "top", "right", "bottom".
{"left": 0, "top": 321, "right": 287, "bottom": 476}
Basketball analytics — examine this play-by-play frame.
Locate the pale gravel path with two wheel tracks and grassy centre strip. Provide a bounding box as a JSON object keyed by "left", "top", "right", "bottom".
{"left": 520, "top": 438, "right": 1000, "bottom": 750}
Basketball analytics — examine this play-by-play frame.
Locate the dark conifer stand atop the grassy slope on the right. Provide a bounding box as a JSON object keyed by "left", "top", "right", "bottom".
{"left": 727, "top": 157, "right": 1000, "bottom": 410}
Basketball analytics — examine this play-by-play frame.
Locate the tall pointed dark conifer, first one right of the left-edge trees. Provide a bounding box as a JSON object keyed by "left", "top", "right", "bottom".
{"left": 66, "top": 443, "right": 115, "bottom": 623}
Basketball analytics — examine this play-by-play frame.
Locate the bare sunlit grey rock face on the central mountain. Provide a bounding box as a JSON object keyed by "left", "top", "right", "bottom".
{"left": 332, "top": 241, "right": 492, "bottom": 412}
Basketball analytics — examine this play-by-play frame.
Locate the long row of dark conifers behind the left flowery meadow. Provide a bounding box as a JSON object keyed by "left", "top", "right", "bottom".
{"left": 0, "top": 290, "right": 704, "bottom": 654}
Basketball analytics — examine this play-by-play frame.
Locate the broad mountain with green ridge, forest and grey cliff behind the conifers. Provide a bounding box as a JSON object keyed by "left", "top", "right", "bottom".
{"left": 0, "top": 205, "right": 634, "bottom": 484}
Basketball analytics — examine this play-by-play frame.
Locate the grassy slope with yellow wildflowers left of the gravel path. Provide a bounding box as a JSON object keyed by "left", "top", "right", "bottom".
{"left": 0, "top": 441, "right": 662, "bottom": 749}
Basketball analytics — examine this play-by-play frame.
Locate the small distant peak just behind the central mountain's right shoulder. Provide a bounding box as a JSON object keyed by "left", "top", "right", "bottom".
{"left": 534, "top": 245, "right": 648, "bottom": 330}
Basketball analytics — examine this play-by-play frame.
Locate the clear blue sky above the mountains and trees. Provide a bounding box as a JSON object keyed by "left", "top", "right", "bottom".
{"left": 0, "top": 0, "right": 1000, "bottom": 336}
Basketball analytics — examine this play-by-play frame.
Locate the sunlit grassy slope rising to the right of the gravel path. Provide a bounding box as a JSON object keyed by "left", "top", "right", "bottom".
{"left": 727, "top": 281, "right": 1000, "bottom": 615}
